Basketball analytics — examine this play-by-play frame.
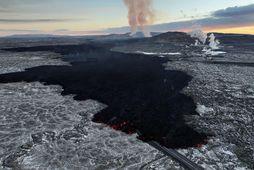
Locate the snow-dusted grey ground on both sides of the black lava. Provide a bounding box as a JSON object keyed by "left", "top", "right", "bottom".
{"left": 0, "top": 37, "right": 254, "bottom": 170}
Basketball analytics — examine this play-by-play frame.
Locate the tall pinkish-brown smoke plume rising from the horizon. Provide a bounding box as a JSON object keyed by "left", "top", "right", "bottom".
{"left": 123, "top": 0, "right": 154, "bottom": 37}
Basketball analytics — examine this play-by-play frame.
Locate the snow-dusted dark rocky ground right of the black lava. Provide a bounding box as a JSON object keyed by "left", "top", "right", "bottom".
{"left": 165, "top": 61, "right": 254, "bottom": 169}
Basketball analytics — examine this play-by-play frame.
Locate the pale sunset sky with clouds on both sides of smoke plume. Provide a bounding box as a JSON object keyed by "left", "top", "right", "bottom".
{"left": 0, "top": 0, "right": 254, "bottom": 36}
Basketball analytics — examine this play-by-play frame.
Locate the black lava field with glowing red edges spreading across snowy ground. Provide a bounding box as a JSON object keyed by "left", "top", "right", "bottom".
{"left": 0, "top": 44, "right": 207, "bottom": 148}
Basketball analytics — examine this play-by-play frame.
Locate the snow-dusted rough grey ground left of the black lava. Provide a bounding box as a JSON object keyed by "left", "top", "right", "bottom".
{"left": 0, "top": 49, "right": 185, "bottom": 170}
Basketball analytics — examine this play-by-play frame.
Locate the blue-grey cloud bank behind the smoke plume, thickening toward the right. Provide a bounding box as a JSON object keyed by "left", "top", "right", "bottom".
{"left": 105, "top": 4, "right": 254, "bottom": 33}
